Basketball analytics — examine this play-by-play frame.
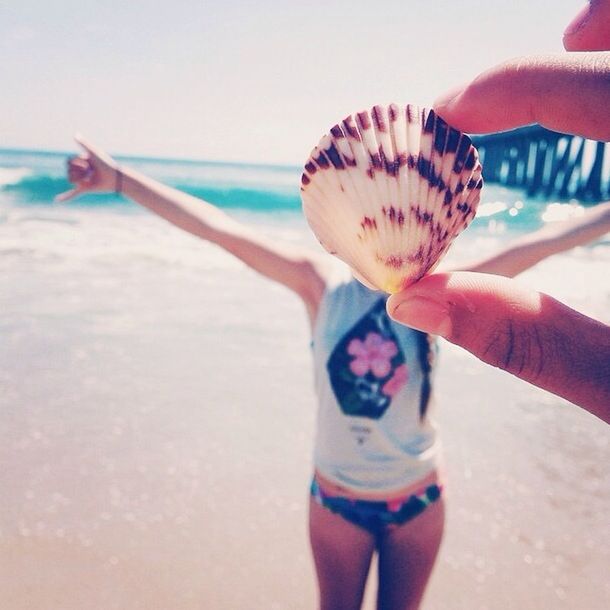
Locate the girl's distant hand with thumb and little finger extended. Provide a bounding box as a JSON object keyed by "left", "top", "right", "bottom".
{"left": 55, "top": 135, "right": 120, "bottom": 202}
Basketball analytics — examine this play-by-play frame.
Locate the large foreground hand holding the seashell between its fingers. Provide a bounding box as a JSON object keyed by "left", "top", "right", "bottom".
{"left": 388, "top": 0, "right": 610, "bottom": 423}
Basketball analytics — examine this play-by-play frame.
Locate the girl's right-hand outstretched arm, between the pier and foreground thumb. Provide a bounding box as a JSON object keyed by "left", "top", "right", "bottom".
{"left": 459, "top": 201, "right": 610, "bottom": 277}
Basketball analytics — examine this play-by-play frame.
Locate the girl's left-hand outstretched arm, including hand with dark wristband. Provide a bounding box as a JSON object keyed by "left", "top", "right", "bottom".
{"left": 57, "top": 137, "right": 329, "bottom": 321}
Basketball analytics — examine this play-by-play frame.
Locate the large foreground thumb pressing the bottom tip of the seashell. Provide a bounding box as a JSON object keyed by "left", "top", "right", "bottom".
{"left": 388, "top": 273, "right": 610, "bottom": 421}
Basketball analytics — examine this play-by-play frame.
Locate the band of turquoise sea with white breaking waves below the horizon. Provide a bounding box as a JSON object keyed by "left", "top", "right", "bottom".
{"left": 0, "top": 149, "right": 592, "bottom": 232}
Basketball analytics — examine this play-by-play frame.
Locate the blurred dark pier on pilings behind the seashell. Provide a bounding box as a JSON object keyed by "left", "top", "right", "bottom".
{"left": 472, "top": 125, "right": 610, "bottom": 203}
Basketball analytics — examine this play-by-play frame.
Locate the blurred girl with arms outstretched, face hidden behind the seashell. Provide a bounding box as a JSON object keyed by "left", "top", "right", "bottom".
{"left": 59, "top": 139, "right": 610, "bottom": 610}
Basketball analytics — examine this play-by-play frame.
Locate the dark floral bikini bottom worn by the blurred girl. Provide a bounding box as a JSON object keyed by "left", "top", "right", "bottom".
{"left": 311, "top": 477, "right": 442, "bottom": 537}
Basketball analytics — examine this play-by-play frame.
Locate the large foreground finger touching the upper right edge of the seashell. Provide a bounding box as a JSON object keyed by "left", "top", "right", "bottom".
{"left": 434, "top": 52, "right": 610, "bottom": 141}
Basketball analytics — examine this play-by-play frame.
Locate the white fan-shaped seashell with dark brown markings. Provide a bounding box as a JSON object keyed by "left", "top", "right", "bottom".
{"left": 301, "top": 104, "right": 483, "bottom": 293}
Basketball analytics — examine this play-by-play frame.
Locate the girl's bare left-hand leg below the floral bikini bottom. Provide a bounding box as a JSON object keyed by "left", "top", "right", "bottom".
{"left": 309, "top": 499, "right": 375, "bottom": 610}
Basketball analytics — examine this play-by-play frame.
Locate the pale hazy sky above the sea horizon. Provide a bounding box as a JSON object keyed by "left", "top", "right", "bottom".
{"left": 0, "top": 0, "right": 584, "bottom": 164}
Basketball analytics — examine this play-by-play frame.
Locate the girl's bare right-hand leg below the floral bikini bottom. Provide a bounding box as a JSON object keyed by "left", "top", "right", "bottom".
{"left": 377, "top": 498, "right": 445, "bottom": 610}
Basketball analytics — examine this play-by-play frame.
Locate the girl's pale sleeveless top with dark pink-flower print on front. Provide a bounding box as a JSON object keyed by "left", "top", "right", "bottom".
{"left": 312, "top": 268, "right": 440, "bottom": 492}
